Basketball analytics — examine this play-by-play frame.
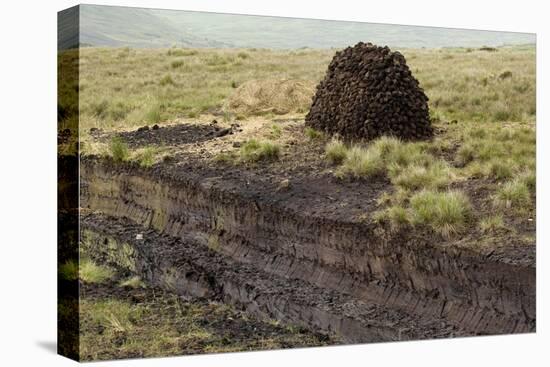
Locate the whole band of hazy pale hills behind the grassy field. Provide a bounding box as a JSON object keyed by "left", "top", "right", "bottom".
{"left": 61, "top": 5, "right": 535, "bottom": 49}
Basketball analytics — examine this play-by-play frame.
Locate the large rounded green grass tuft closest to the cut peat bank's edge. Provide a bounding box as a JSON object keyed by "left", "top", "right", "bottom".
{"left": 410, "top": 190, "right": 471, "bottom": 237}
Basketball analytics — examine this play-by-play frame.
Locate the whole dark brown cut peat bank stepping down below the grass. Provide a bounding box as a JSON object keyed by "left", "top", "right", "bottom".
{"left": 81, "top": 158, "right": 536, "bottom": 341}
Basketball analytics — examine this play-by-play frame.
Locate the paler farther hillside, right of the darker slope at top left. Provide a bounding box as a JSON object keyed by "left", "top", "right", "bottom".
{"left": 151, "top": 10, "right": 535, "bottom": 48}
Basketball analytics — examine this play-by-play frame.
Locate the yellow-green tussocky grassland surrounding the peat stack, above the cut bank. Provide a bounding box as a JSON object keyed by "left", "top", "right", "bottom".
{"left": 68, "top": 46, "right": 536, "bottom": 242}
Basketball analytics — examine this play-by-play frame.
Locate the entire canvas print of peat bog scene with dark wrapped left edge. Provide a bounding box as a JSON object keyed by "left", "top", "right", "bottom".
{"left": 57, "top": 5, "right": 536, "bottom": 361}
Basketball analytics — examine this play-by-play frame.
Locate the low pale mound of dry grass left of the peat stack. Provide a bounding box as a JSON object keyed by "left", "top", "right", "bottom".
{"left": 225, "top": 79, "right": 315, "bottom": 115}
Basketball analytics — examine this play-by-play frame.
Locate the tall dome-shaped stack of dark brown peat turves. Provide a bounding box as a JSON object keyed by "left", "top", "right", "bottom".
{"left": 306, "top": 42, "right": 433, "bottom": 140}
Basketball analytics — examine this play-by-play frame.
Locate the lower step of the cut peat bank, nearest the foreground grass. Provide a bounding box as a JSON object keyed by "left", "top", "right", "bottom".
{"left": 81, "top": 215, "right": 464, "bottom": 342}
